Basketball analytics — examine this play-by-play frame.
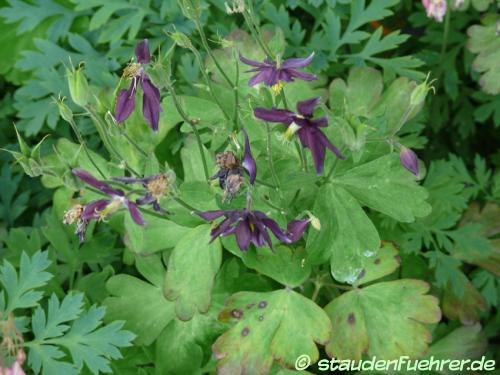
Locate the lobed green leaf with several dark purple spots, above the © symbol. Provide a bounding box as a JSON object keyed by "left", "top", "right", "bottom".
{"left": 212, "top": 289, "right": 331, "bottom": 375}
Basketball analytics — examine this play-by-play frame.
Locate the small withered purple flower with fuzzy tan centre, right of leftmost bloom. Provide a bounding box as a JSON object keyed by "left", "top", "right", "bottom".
{"left": 113, "top": 173, "right": 174, "bottom": 214}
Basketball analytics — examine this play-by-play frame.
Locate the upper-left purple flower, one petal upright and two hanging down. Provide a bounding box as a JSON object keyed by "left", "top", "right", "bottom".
{"left": 115, "top": 39, "right": 162, "bottom": 132}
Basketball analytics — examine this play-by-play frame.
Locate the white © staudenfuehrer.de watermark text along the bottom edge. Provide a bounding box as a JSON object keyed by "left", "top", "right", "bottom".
{"left": 295, "top": 354, "right": 496, "bottom": 372}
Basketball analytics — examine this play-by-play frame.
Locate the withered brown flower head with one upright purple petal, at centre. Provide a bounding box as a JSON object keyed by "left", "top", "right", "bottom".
{"left": 211, "top": 129, "right": 257, "bottom": 200}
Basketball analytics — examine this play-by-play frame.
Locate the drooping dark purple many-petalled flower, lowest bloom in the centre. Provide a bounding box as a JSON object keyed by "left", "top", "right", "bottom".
{"left": 197, "top": 209, "right": 292, "bottom": 251}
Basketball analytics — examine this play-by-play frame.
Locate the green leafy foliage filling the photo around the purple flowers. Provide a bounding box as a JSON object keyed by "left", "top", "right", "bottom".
{"left": 0, "top": 0, "right": 500, "bottom": 374}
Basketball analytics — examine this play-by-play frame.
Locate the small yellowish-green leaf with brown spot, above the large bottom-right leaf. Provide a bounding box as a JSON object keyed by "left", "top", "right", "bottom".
{"left": 355, "top": 241, "right": 401, "bottom": 285}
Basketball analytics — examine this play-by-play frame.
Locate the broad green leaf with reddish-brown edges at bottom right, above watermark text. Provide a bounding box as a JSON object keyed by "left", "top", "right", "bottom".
{"left": 325, "top": 279, "right": 441, "bottom": 360}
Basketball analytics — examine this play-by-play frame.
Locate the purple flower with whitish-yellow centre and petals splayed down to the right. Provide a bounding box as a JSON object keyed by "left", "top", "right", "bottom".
{"left": 254, "top": 97, "right": 344, "bottom": 175}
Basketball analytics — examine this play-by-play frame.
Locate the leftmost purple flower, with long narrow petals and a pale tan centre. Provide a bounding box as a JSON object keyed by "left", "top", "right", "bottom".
{"left": 63, "top": 169, "right": 146, "bottom": 242}
